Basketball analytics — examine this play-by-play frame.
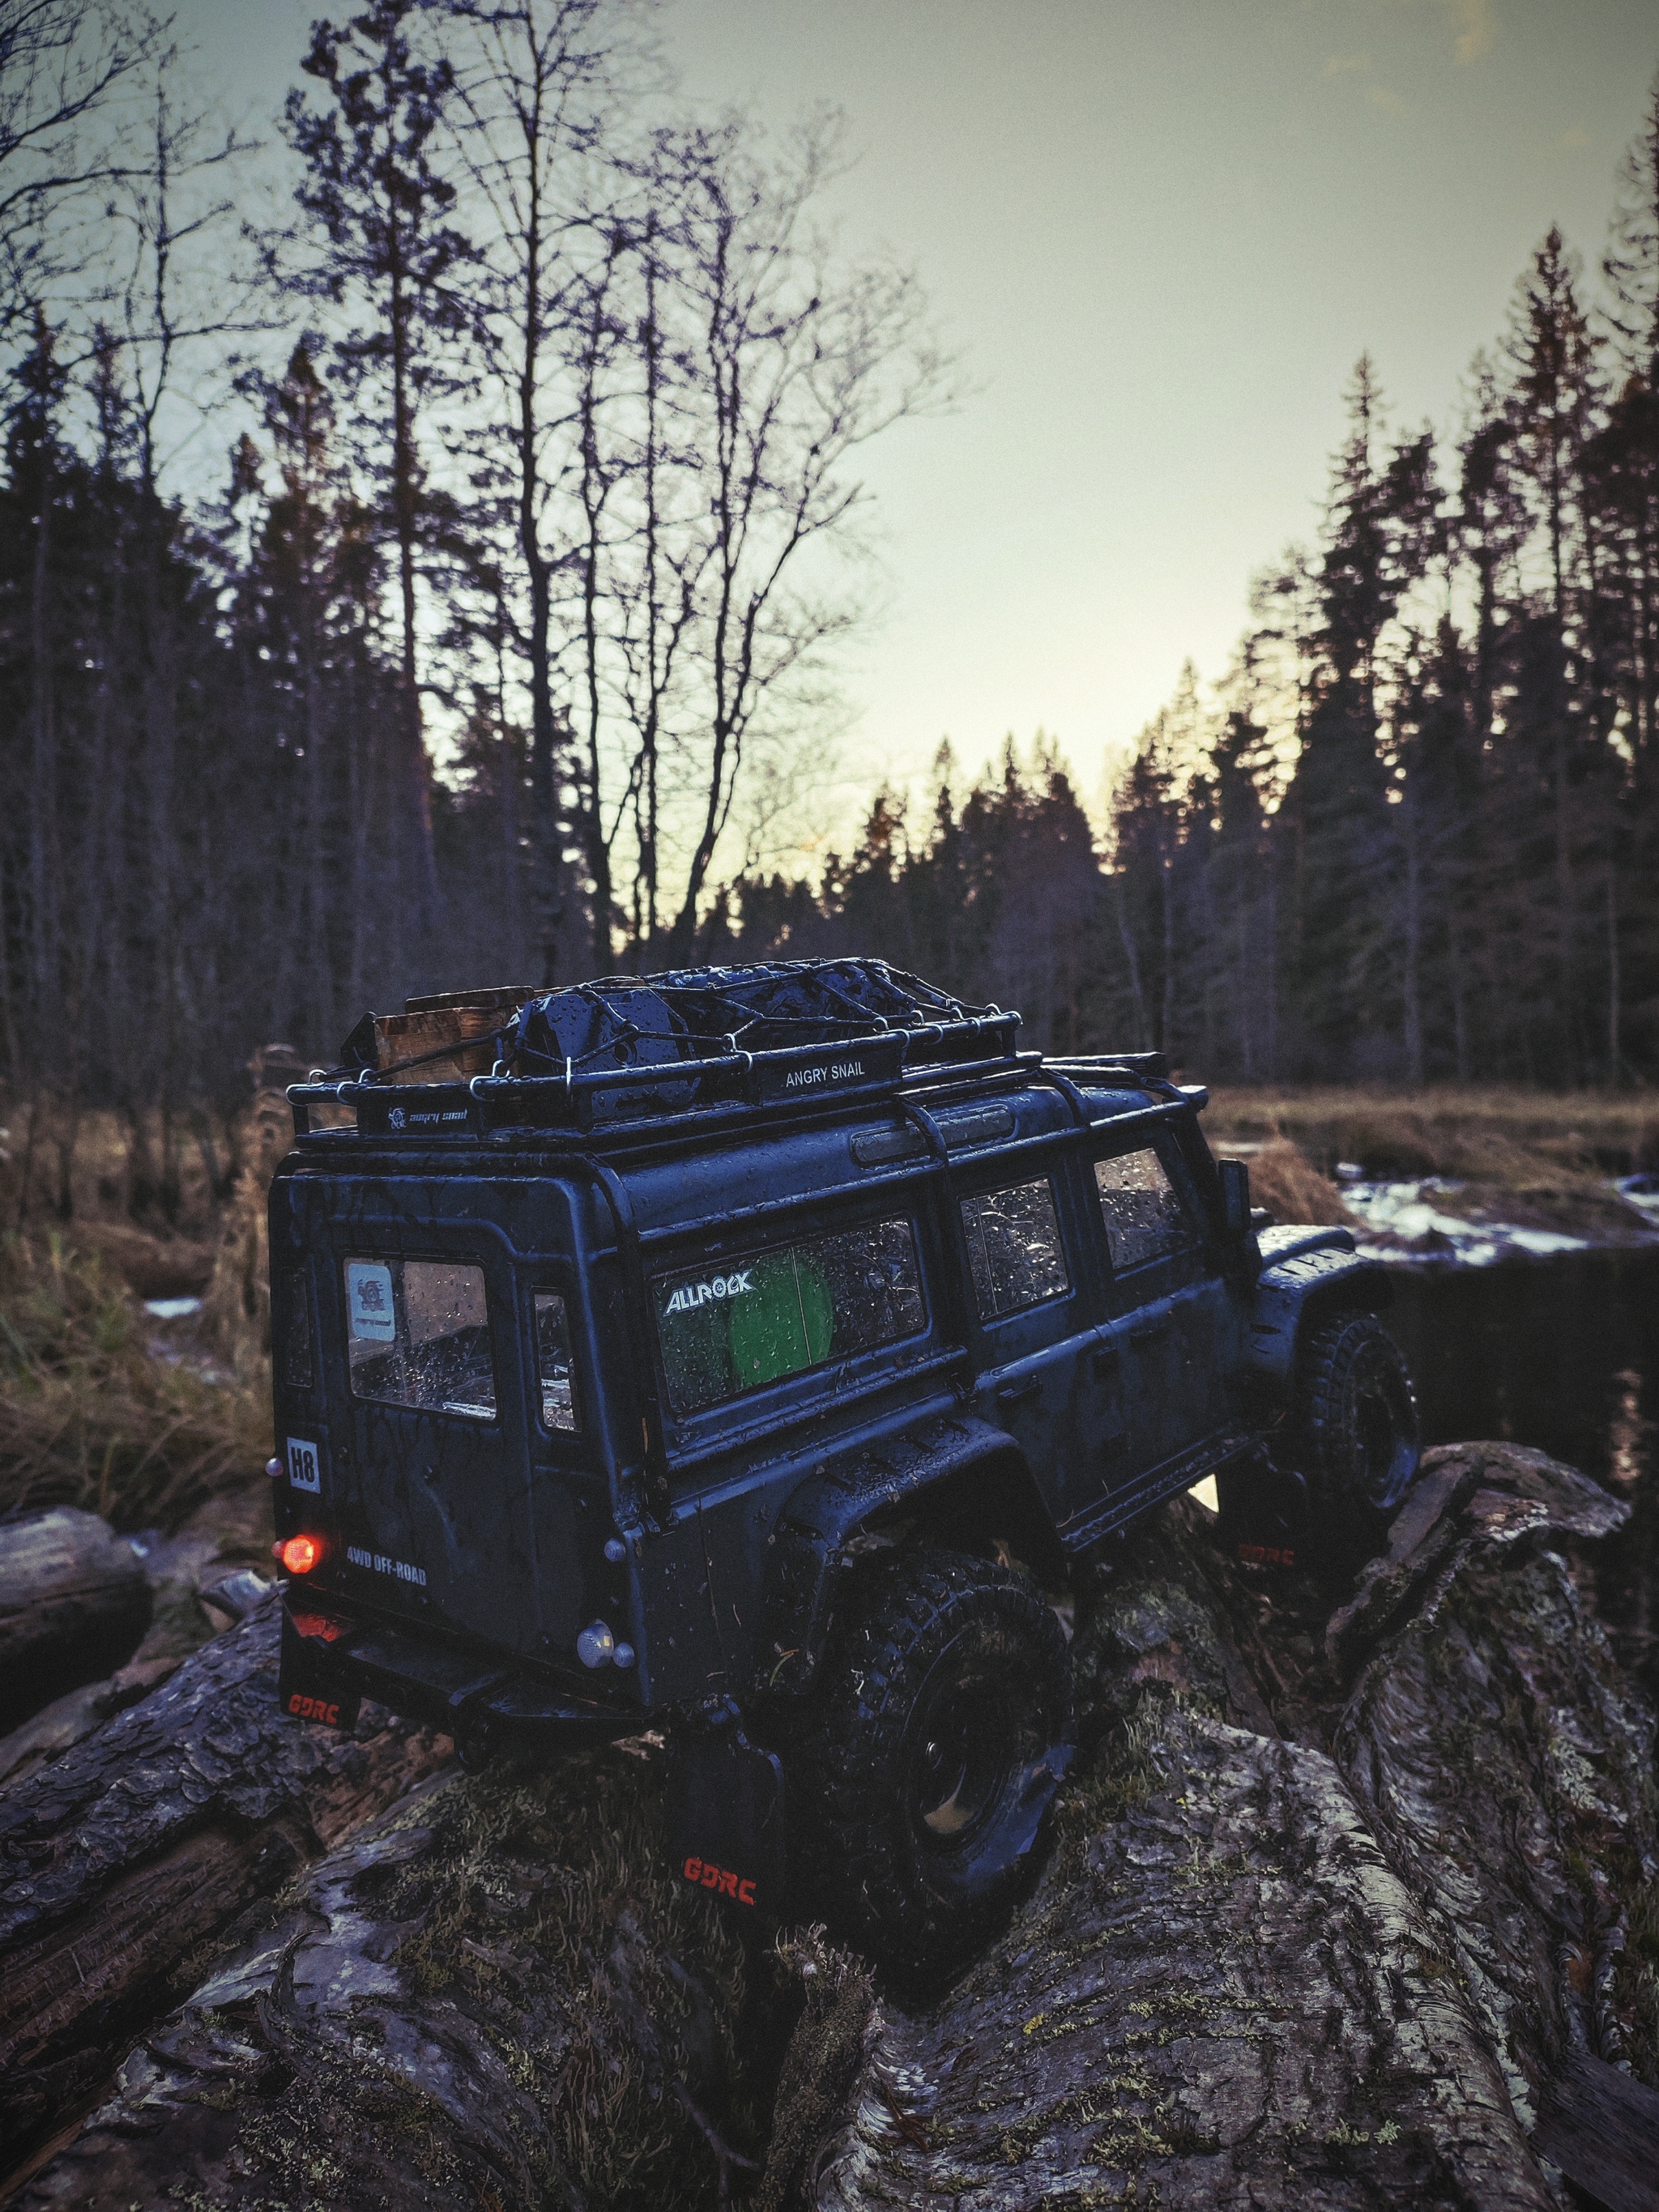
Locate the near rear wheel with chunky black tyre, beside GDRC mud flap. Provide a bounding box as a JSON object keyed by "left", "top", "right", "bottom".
{"left": 792, "top": 1550, "right": 1071, "bottom": 1969}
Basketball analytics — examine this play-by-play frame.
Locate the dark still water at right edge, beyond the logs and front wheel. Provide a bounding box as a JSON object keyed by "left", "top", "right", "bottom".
{"left": 1384, "top": 1246, "right": 1659, "bottom": 1697}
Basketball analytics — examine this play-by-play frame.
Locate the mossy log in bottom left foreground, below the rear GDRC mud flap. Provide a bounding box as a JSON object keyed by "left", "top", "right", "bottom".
{"left": 22, "top": 1747, "right": 783, "bottom": 2212}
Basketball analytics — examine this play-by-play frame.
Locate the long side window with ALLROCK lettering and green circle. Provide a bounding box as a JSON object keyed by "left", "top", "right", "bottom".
{"left": 653, "top": 1221, "right": 927, "bottom": 1413}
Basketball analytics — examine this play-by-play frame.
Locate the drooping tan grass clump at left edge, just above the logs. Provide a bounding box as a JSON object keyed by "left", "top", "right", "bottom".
{"left": 0, "top": 1232, "right": 270, "bottom": 1528}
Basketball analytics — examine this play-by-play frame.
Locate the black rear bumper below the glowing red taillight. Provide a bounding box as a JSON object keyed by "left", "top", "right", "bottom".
{"left": 284, "top": 1588, "right": 646, "bottom": 1743}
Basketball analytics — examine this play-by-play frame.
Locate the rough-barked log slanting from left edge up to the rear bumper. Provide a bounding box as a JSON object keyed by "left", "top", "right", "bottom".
{"left": 0, "top": 1600, "right": 451, "bottom": 2175}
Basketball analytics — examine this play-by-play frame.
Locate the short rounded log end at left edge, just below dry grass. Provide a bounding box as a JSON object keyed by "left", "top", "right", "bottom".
{"left": 0, "top": 1507, "right": 151, "bottom": 1737}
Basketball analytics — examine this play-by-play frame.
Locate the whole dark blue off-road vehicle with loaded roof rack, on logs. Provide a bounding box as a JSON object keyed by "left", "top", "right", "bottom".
{"left": 270, "top": 962, "right": 1416, "bottom": 1940}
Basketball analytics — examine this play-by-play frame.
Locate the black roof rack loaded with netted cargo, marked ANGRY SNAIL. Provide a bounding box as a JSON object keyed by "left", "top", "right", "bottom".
{"left": 288, "top": 960, "right": 1038, "bottom": 1137}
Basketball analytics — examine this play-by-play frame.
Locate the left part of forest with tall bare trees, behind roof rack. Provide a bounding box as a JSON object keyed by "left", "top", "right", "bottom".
{"left": 0, "top": 0, "right": 949, "bottom": 1176}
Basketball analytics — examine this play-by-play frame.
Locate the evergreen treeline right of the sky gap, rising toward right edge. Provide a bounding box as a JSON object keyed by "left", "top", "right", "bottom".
{"left": 743, "top": 104, "right": 1659, "bottom": 1086}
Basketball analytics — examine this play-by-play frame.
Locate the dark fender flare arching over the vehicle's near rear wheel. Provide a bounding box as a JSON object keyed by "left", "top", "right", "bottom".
{"left": 754, "top": 1413, "right": 1064, "bottom": 1694}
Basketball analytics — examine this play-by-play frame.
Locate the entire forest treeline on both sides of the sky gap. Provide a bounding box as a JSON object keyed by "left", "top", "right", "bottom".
{"left": 0, "top": 0, "right": 1659, "bottom": 1221}
